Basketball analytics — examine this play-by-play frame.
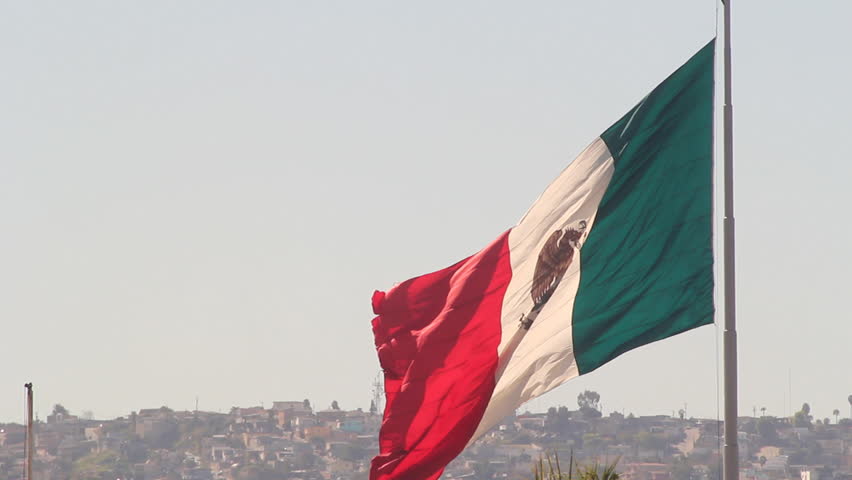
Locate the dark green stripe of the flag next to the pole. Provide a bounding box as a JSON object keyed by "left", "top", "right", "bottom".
{"left": 573, "top": 41, "right": 715, "bottom": 374}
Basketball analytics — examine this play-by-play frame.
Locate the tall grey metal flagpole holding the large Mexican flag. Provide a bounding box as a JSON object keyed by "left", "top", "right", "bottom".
{"left": 722, "top": 0, "right": 739, "bottom": 480}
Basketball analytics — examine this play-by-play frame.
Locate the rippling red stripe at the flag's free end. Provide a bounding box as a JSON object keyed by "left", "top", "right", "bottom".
{"left": 370, "top": 232, "right": 512, "bottom": 480}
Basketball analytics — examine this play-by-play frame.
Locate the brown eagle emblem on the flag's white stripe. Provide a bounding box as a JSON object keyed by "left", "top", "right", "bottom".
{"left": 521, "top": 220, "right": 587, "bottom": 330}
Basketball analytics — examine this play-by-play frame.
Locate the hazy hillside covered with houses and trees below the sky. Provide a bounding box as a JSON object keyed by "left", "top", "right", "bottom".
{"left": 0, "top": 391, "right": 852, "bottom": 480}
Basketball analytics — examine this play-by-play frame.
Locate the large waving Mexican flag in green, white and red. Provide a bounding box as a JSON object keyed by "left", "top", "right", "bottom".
{"left": 370, "top": 41, "right": 714, "bottom": 480}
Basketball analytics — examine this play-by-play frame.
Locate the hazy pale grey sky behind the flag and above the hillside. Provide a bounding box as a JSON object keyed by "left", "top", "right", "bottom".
{"left": 0, "top": 0, "right": 852, "bottom": 422}
